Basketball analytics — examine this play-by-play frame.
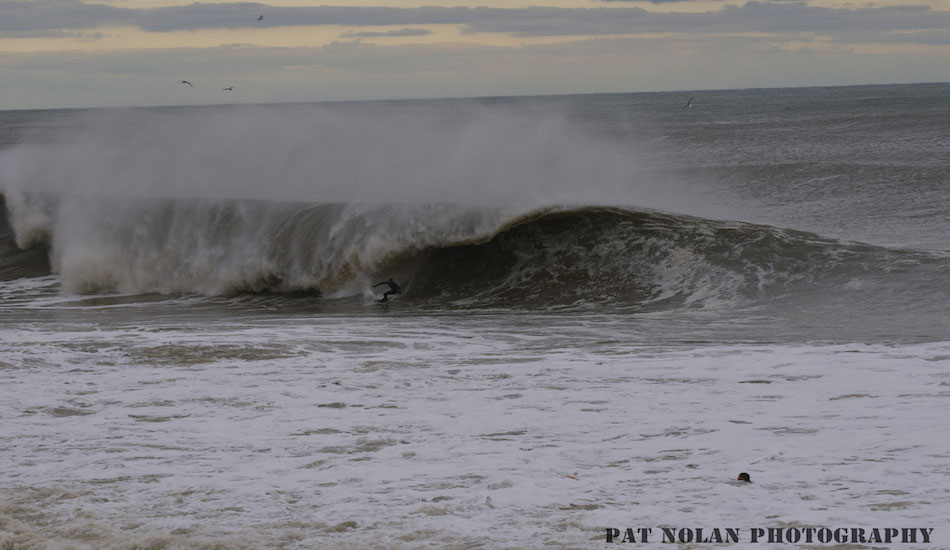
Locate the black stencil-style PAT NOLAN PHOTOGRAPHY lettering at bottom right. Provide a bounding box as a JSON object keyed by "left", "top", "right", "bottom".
{"left": 607, "top": 527, "right": 934, "bottom": 545}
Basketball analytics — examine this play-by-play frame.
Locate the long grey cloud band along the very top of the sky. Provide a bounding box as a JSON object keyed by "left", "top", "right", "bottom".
{"left": 0, "top": 0, "right": 950, "bottom": 40}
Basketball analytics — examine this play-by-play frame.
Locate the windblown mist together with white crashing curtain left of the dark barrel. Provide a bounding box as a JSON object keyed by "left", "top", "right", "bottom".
{"left": 0, "top": 104, "right": 700, "bottom": 295}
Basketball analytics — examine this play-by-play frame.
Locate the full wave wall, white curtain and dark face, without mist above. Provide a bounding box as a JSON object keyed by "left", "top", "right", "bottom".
{"left": 3, "top": 192, "right": 926, "bottom": 310}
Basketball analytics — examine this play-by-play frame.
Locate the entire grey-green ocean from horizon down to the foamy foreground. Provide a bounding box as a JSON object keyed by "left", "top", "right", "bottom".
{"left": 0, "top": 84, "right": 950, "bottom": 549}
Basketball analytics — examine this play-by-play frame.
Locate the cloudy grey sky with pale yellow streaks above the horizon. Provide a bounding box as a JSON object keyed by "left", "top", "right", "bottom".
{"left": 0, "top": 0, "right": 950, "bottom": 109}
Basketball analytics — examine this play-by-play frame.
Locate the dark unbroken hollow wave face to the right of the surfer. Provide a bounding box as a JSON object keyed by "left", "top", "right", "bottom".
{"left": 417, "top": 207, "right": 933, "bottom": 310}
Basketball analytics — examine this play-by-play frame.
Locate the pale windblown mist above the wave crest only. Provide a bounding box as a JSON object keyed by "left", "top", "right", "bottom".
{"left": 2, "top": 104, "right": 681, "bottom": 210}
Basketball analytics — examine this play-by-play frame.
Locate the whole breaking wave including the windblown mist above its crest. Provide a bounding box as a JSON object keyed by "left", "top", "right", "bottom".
{"left": 0, "top": 102, "right": 942, "bottom": 310}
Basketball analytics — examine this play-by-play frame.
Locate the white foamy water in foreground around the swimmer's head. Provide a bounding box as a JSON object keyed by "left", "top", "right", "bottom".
{"left": 0, "top": 315, "right": 950, "bottom": 548}
